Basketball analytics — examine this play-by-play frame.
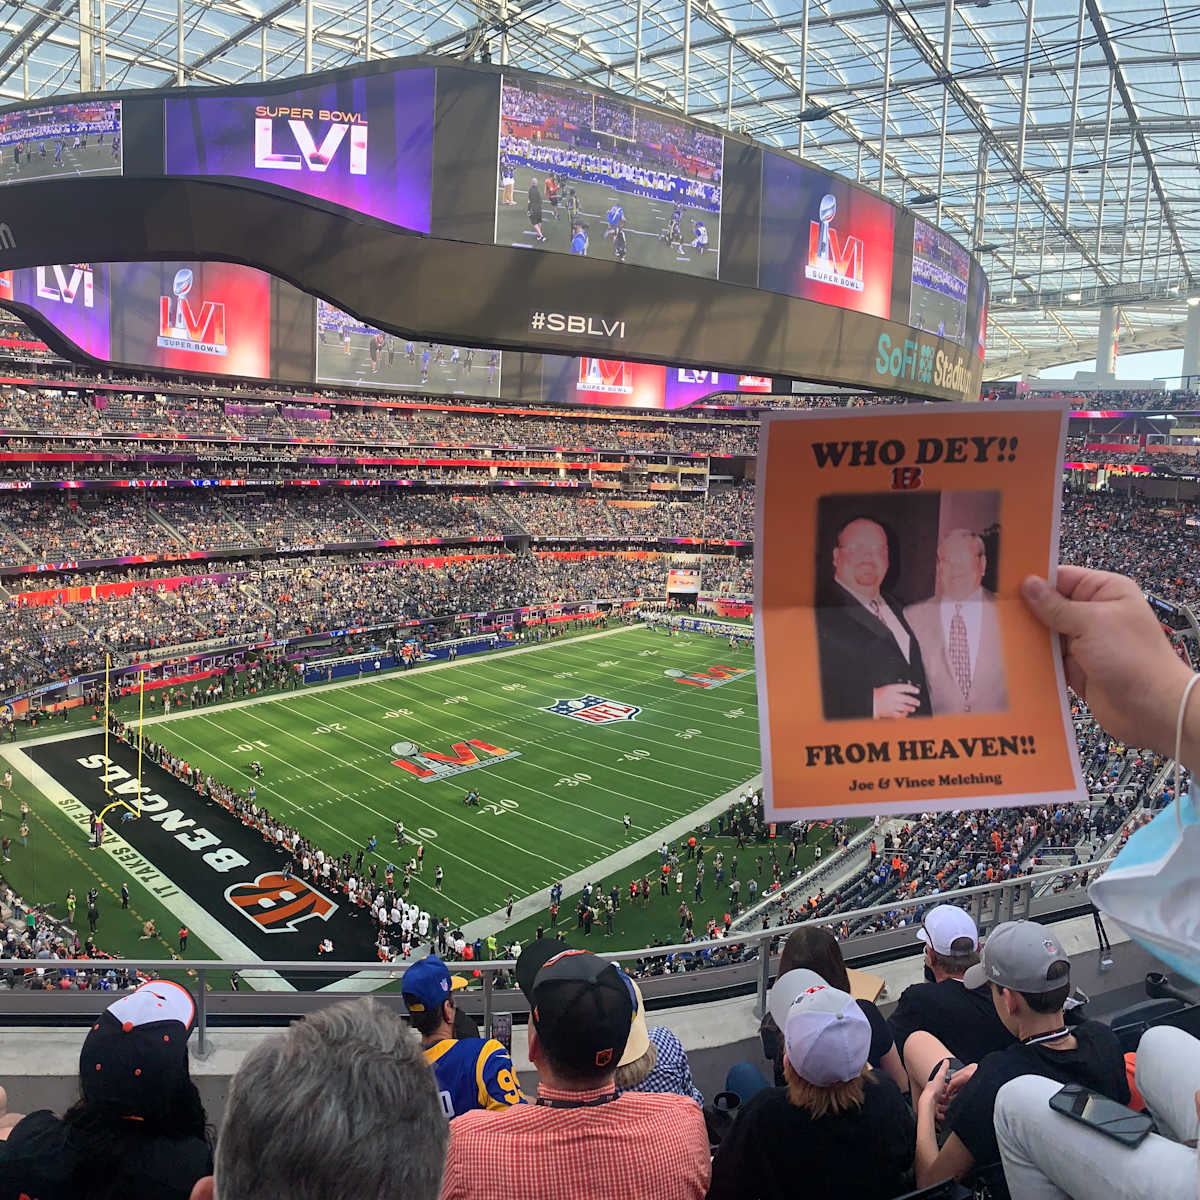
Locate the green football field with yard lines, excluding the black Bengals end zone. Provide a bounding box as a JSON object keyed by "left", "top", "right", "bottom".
{"left": 146, "top": 628, "right": 760, "bottom": 924}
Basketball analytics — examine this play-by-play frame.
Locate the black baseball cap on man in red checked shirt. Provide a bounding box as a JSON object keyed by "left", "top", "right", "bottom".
{"left": 516, "top": 938, "right": 634, "bottom": 1072}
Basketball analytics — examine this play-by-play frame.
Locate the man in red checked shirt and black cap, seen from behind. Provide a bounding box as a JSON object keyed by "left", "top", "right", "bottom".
{"left": 442, "top": 940, "right": 710, "bottom": 1200}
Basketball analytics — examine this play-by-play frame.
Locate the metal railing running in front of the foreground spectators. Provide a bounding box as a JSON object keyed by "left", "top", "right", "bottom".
{"left": 0, "top": 857, "right": 1112, "bottom": 1058}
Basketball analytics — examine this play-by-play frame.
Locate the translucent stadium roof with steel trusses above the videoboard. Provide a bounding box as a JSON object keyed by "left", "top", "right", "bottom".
{"left": 0, "top": 0, "right": 1200, "bottom": 377}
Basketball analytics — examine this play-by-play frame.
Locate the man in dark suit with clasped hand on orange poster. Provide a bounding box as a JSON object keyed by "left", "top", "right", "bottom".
{"left": 817, "top": 517, "right": 931, "bottom": 720}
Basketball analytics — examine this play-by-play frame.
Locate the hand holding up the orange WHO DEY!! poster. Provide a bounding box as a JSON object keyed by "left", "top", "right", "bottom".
{"left": 1021, "top": 566, "right": 1200, "bottom": 767}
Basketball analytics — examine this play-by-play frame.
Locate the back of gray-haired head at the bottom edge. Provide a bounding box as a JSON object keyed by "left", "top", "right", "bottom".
{"left": 191, "top": 997, "right": 448, "bottom": 1200}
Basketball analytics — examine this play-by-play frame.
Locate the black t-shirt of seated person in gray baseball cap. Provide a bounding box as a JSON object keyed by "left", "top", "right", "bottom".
{"left": 946, "top": 1021, "right": 1129, "bottom": 1166}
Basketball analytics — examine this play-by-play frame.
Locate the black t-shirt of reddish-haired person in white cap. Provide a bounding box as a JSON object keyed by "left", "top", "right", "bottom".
{"left": 708, "top": 1073, "right": 916, "bottom": 1200}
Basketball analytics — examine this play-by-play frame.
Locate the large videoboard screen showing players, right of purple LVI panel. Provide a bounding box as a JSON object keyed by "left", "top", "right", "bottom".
{"left": 496, "top": 76, "right": 724, "bottom": 280}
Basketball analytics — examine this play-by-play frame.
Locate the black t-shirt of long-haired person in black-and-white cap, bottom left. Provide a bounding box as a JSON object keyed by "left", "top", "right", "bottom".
{"left": 0, "top": 1109, "right": 212, "bottom": 1200}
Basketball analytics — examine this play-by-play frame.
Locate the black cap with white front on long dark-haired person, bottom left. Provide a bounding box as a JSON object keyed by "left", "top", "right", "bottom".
{"left": 79, "top": 979, "right": 196, "bottom": 1117}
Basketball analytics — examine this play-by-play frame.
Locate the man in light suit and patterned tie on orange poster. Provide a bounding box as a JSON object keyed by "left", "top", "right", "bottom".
{"left": 904, "top": 529, "right": 1008, "bottom": 716}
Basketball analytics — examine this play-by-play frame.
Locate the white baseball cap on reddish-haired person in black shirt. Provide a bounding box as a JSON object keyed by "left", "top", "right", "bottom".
{"left": 767, "top": 967, "right": 871, "bottom": 1087}
